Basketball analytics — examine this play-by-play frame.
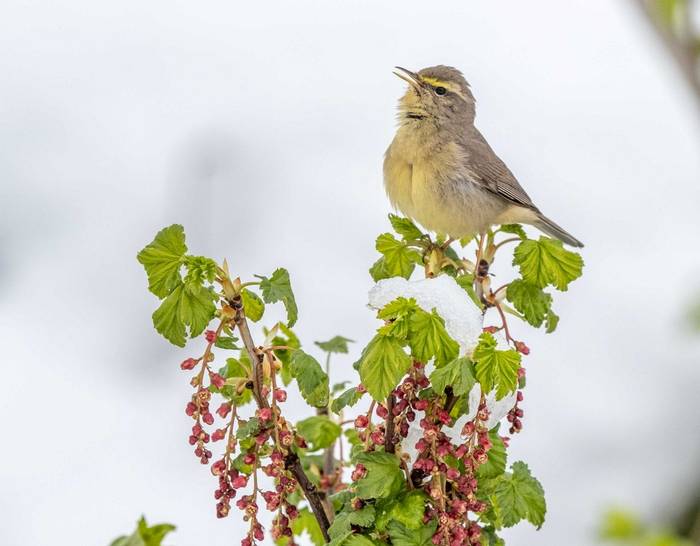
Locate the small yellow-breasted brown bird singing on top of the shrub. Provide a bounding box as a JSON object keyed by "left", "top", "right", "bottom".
{"left": 384, "top": 65, "right": 583, "bottom": 247}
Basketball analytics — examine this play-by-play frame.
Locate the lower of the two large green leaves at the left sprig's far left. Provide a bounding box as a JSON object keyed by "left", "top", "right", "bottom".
{"left": 153, "top": 283, "right": 216, "bottom": 347}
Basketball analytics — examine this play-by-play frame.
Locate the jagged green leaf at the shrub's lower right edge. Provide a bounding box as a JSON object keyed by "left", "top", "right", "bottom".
{"left": 494, "top": 461, "right": 547, "bottom": 529}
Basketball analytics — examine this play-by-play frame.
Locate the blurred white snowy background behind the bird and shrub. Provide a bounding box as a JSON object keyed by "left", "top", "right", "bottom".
{"left": 0, "top": 0, "right": 700, "bottom": 546}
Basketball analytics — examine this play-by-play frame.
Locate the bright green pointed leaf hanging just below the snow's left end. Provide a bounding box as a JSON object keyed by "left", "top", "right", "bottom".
{"left": 359, "top": 335, "right": 411, "bottom": 402}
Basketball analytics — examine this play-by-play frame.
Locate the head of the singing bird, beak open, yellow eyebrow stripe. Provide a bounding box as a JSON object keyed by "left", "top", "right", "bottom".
{"left": 394, "top": 65, "right": 475, "bottom": 125}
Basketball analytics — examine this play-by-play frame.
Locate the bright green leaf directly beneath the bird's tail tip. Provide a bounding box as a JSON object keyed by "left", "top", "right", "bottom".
{"left": 513, "top": 236, "right": 583, "bottom": 291}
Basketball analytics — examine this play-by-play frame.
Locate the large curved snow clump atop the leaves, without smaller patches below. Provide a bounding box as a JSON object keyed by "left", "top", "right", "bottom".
{"left": 369, "top": 275, "right": 484, "bottom": 354}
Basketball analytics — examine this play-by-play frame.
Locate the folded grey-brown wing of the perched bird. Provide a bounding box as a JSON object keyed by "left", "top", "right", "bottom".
{"left": 465, "top": 129, "right": 537, "bottom": 210}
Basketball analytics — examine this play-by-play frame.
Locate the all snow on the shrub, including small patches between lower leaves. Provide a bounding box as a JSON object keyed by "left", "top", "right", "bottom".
{"left": 369, "top": 275, "right": 517, "bottom": 463}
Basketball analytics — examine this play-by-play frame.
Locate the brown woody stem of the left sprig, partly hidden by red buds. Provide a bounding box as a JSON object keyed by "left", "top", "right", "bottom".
{"left": 228, "top": 296, "right": 330, "bottom": 542}
